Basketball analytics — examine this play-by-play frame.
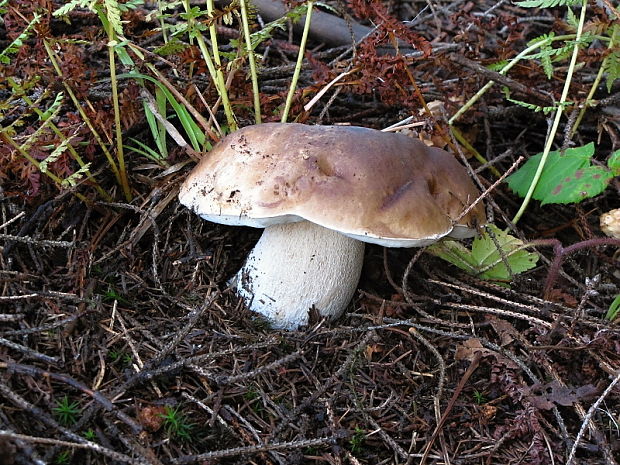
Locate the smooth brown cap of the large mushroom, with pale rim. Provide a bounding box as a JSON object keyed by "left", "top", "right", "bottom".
{"left": 179, "top": 123, "right": 486, "bottom": 247}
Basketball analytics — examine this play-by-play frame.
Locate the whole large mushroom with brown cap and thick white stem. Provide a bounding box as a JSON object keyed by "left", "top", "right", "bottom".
{"left": 179, "top": 123, "right": 486, "bottom": 329}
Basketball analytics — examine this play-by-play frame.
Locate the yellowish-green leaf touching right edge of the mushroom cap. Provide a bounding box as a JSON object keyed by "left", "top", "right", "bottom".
{"left": 426, "top": 225, "right": 538, "bottom": 281}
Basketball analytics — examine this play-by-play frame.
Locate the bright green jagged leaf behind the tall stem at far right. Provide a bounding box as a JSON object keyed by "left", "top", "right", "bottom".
{"left": 506, "top": 143, "right": 615, "bottom": 205}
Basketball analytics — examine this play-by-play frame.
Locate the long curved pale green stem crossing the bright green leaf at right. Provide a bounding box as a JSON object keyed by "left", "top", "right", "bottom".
{"left": 512, "top": 0, "right": 588, "bottom": 224}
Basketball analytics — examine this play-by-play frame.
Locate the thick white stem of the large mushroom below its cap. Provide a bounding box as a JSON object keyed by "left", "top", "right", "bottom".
{"left": 235, "top": 221, "right": 364, "bottom": 329}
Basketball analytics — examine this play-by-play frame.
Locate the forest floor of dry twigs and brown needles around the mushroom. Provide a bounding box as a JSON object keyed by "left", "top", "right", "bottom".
{"left": 0, "top": 1, "right": 620, "bottom": 464}
